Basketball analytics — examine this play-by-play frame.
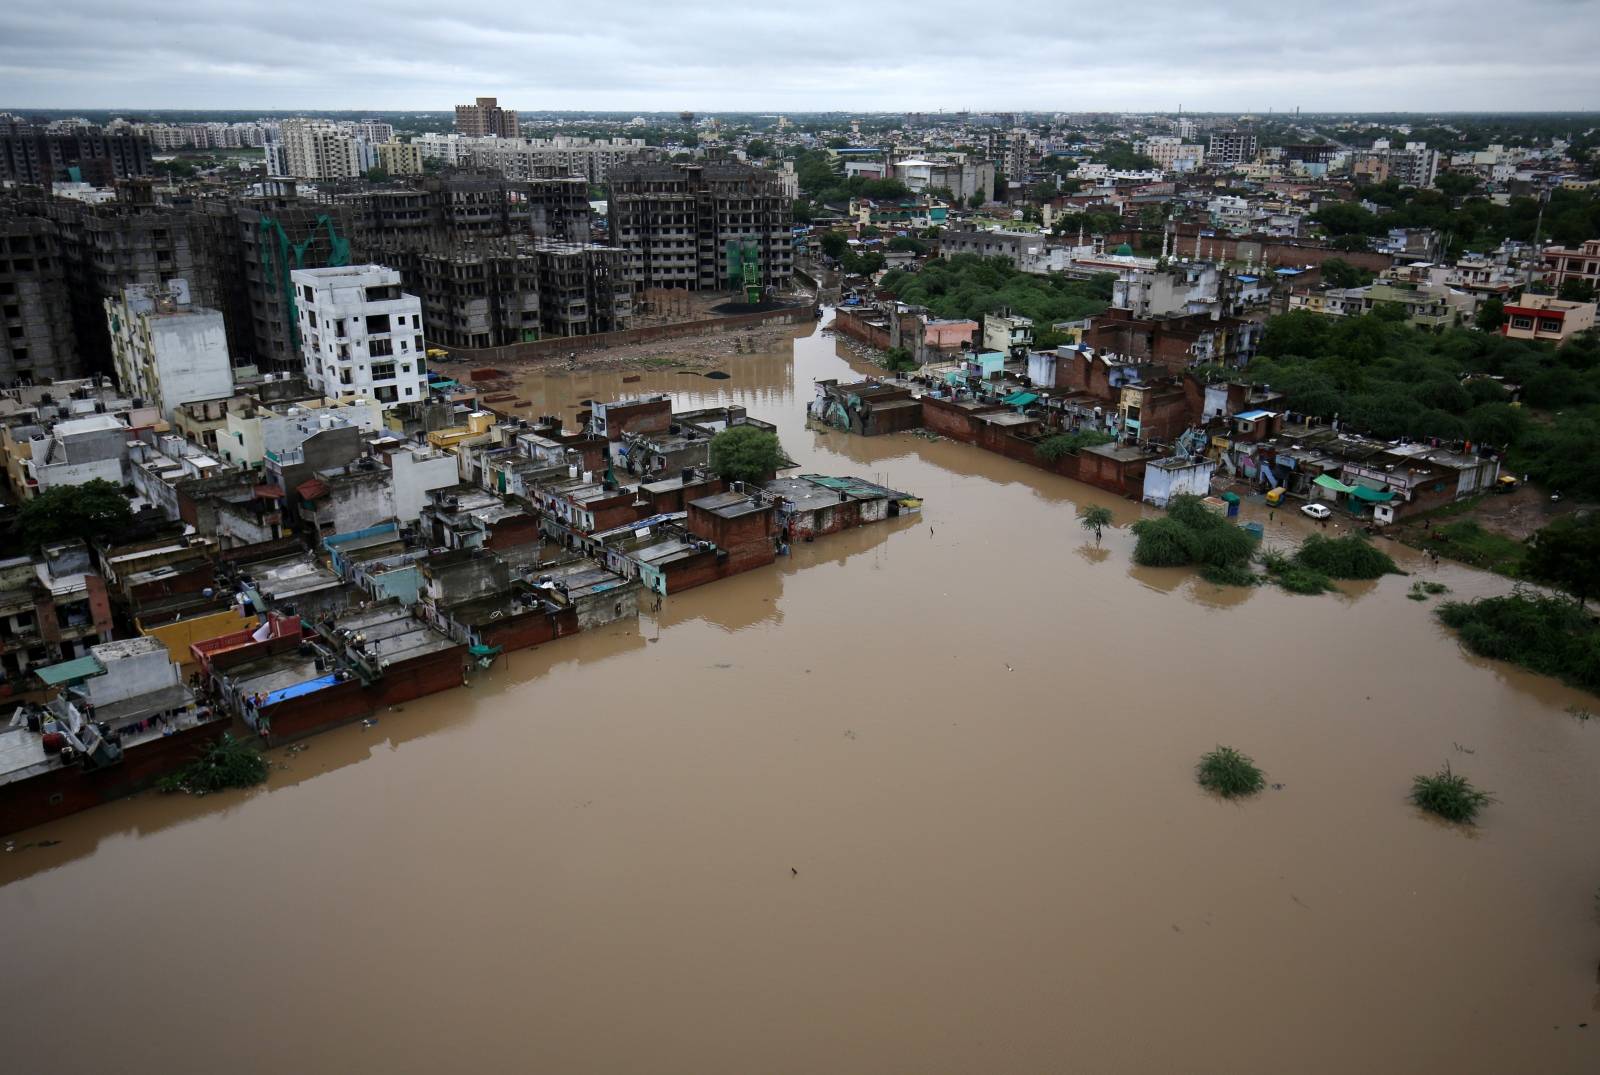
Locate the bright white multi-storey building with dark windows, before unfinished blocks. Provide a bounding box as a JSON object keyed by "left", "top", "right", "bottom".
{"left": 290, "top": 266, "right": 427, "bottom": 410}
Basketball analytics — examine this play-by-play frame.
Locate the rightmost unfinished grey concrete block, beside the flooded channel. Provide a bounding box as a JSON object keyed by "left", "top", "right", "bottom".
{"left": 608, "top": 160, "right": 794, "bottom": 291}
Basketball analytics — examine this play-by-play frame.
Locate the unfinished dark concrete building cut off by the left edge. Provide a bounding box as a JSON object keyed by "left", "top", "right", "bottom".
{"left": 0, "top": 210, "right": 80, "bottom": 386}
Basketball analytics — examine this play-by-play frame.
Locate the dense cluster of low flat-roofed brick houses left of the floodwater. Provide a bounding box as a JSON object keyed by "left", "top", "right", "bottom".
{"left": 0, "top": 367, "right": 920, "bottom": 829}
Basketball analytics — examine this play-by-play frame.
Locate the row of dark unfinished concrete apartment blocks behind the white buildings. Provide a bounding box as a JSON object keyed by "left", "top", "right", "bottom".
{"left": 0, "top": 162, "right": 810, "bottom": 384}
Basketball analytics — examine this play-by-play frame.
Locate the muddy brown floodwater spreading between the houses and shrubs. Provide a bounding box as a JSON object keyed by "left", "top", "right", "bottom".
{"left": 0, "top": 315, "right": 1600, "bottom": 1075}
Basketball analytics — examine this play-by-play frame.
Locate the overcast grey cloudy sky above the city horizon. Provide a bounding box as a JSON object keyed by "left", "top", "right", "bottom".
{"left": 0, "top": 0, "right": 1600, "bottom": 112}
